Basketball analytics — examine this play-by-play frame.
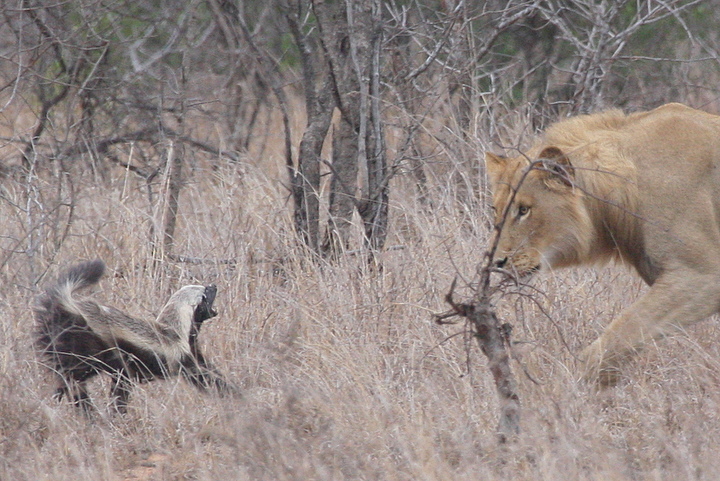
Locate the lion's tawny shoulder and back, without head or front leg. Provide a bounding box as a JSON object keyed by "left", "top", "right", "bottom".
{"left": 545, "top": 103, "right": 720, "bottom": 279}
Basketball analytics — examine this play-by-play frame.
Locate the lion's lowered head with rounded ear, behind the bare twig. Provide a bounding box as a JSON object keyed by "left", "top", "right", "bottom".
{"left": 486, "top": 147, "right": 592, "bottom": 277}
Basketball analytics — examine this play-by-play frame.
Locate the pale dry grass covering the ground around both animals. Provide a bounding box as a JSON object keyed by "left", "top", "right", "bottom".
{"left": 0, "top": 118, "right": 720, "bottom": 481}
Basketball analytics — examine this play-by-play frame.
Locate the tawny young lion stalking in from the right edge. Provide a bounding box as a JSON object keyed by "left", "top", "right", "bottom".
{"left": 486, "top": 103, "right": 720, "bottom": 386}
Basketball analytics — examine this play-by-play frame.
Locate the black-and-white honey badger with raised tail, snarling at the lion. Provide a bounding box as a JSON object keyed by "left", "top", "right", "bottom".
{"left": 34, "top": 260, "right": 238, "bottom": 413}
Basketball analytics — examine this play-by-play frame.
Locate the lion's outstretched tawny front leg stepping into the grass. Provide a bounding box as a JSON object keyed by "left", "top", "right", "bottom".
{"left": 580, "top": 270, "right": 720, "bottom": 387}
